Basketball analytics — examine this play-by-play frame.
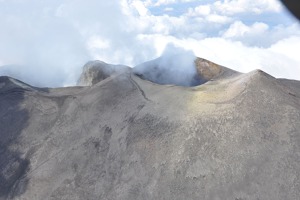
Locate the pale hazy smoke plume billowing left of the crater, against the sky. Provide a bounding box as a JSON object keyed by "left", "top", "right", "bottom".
{"left": 0, "top": 0, "right": 154, "bottom": 87}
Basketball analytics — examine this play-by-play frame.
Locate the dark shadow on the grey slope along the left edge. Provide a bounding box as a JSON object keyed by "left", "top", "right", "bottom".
{"left": 0, "top": 77, "right": 33, "bottom": 199}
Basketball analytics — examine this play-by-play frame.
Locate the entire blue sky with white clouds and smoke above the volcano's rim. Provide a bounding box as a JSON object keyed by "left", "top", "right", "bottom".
{"left": 0, "top": 0, "right": 300, "bottom": 87}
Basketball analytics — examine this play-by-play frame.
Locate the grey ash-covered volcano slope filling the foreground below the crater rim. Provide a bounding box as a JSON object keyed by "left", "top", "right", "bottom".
{"left": 0, "top": 58, "right": 300, "bottom": 200}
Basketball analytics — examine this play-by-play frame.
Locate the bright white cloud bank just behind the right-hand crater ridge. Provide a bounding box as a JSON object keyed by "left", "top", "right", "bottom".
{"left": 138, "top": 35, "right": 300, "bottom": 80}
